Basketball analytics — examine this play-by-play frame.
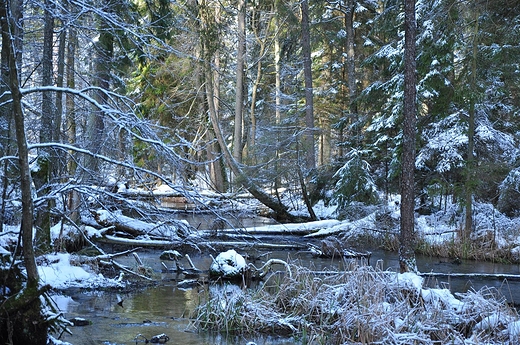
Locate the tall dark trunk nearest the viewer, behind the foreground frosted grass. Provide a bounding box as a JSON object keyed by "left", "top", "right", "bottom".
{"left": 399, "top": 0, "right": 417, "bottom": 272}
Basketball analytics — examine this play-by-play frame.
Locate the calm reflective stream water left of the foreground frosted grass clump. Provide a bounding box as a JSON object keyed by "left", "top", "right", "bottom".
{"left": 54, "top": 251, "right": 298, "bottom": 345}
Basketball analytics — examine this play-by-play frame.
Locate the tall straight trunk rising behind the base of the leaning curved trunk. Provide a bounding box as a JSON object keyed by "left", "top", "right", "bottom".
{"left": 301, "top": 0, "right": 316, "bottom": 170}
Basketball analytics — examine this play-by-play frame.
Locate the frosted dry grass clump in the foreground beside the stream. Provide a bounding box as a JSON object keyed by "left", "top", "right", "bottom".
{"left": 192, "top": 263, "right": 518, "bottom": 344}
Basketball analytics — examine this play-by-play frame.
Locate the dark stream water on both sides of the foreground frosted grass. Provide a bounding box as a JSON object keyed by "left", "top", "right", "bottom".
{"left": 56, "top": 239, "right": 520, "bottom": 345}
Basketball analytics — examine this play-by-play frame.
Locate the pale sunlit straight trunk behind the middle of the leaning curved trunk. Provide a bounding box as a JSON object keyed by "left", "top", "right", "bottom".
{"left": 233, "top": 0, "right": 246, "bottom": 163}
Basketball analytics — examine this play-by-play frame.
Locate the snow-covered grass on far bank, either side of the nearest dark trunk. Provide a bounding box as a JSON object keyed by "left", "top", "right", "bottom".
{"left": 309, "top": 196, "right": 520, "bottom": 262}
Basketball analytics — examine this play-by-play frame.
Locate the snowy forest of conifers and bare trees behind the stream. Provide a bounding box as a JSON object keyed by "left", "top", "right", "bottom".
{"left": 0, "top": 0, "right": 520, "bottom": 344}
